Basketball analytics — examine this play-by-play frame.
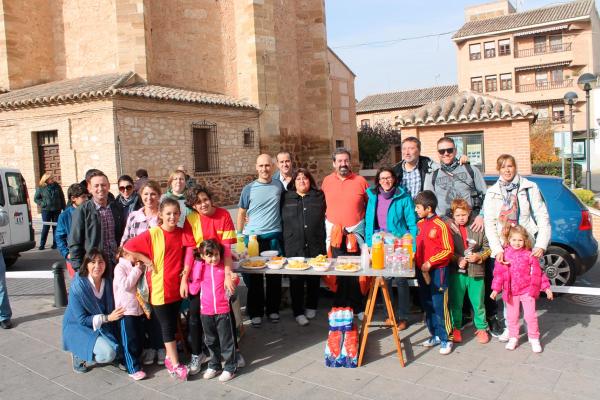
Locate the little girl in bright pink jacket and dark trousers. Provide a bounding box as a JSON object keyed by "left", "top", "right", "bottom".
{"left": 189, "top": 239, "right": 237, "bottom": 382}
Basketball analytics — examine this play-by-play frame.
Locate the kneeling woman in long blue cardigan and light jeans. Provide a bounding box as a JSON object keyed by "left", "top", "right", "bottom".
{"left": 62, "top": 249, "right": 124, "bottom": 373}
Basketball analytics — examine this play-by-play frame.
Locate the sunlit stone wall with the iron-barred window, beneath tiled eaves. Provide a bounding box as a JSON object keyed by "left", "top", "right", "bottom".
{"left": 115, "top": 98, "right": 259, "bottom": 191}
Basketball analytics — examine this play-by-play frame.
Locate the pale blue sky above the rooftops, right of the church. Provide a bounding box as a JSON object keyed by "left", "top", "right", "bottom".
{"left": 325, "top": 0, "right": 599, "bottom": 101}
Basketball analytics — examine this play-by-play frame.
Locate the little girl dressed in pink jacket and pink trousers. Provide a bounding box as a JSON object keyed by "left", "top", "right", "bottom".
{"left": 490, "top": 225, "right": 553, "bottom": 353}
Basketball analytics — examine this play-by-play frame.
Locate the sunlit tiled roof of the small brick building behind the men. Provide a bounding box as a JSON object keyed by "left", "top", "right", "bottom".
{"left": 396, "top": 91, "right": 535, "bottom": 127}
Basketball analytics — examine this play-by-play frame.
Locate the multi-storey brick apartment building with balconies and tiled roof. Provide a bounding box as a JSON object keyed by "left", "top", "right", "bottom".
{"left": 453, "top": 0, "right": 600, "bottom": 168}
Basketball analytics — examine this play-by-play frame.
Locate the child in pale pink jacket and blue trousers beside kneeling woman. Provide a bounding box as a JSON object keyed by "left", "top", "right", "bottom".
{"left": 113, "top": 248, "right": 146, "bottom": 381}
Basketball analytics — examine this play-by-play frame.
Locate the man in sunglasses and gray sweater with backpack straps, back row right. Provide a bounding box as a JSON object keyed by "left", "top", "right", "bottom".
{"left": 424, "top": 137, "right": 487, "bottom": 232}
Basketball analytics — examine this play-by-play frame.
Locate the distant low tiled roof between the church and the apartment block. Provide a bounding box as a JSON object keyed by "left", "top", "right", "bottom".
{"left": 356, "top": 85, "right": 458, "bottom": 113}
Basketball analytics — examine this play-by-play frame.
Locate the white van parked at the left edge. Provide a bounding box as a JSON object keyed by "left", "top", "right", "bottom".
{"left": 0, "top": 168, "right": 35, "bottom": 267}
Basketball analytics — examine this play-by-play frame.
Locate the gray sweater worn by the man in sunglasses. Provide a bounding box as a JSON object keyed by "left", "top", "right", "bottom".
{"left": 423, "top": 165, "right": 487, "bottom": 216}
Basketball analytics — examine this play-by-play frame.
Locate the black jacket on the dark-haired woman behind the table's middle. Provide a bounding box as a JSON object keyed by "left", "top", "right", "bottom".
{"left": 281, "top": 189, "right": 326, "bottom": 257}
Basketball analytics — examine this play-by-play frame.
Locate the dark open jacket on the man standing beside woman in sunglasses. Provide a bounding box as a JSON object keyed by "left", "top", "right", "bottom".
{"left": 68, "top": 200, "right": 125, "bottom": 269}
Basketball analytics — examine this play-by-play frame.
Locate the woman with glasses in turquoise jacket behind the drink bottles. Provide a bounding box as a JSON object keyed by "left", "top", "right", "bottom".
{"left": 365, "top": 167, "right": 417, "bottom": 330}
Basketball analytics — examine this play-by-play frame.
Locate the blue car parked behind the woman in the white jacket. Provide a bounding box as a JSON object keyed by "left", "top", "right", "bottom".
{"left": 484, "top": 175, "right": 598, "bottom": 286}
